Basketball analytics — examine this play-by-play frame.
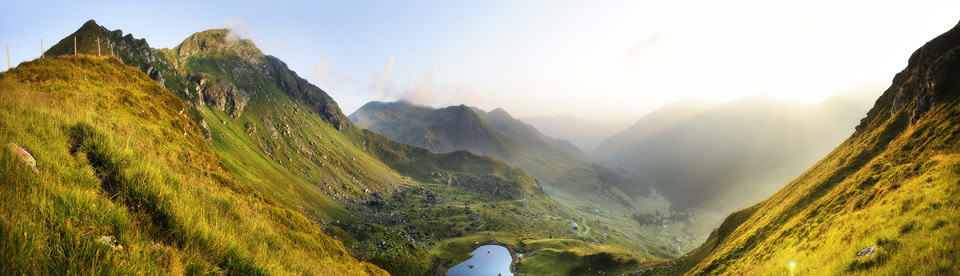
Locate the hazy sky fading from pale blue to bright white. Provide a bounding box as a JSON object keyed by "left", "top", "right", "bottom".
{"left": 0, "top": 0, "right": 960, "bottom": 121}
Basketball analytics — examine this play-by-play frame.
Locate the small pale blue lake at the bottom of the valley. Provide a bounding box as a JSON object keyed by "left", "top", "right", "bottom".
{"left": 447, "top": 245, "right": 513, "bottom": 276}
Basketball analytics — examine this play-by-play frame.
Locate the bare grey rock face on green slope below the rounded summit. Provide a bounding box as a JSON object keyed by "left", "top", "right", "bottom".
{"left": 190, "top": 75, "right": 250, "bottom": 118}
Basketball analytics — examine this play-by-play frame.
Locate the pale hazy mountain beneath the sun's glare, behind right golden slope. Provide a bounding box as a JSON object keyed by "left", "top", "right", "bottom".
{"left": 595, "top": 94, "right": 867, "bottom": 213}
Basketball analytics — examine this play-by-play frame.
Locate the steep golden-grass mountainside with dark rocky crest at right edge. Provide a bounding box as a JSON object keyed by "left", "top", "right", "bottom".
{"left": 646, "top": 19, "right": 960, "bottom": 275}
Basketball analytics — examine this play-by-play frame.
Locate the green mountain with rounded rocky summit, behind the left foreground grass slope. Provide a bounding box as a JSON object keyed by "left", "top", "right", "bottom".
{"left": 39, "top": 22, "right": 663, "bottom": 275}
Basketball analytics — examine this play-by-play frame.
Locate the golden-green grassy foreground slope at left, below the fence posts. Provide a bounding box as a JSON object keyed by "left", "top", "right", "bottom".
{"left": 0, "top": 56, "right": 385, "bottom": 275}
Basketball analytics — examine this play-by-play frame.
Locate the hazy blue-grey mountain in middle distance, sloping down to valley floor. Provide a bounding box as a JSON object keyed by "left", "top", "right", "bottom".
{"left": 349, "top": 101, "right": 686, "bottom": 254}
